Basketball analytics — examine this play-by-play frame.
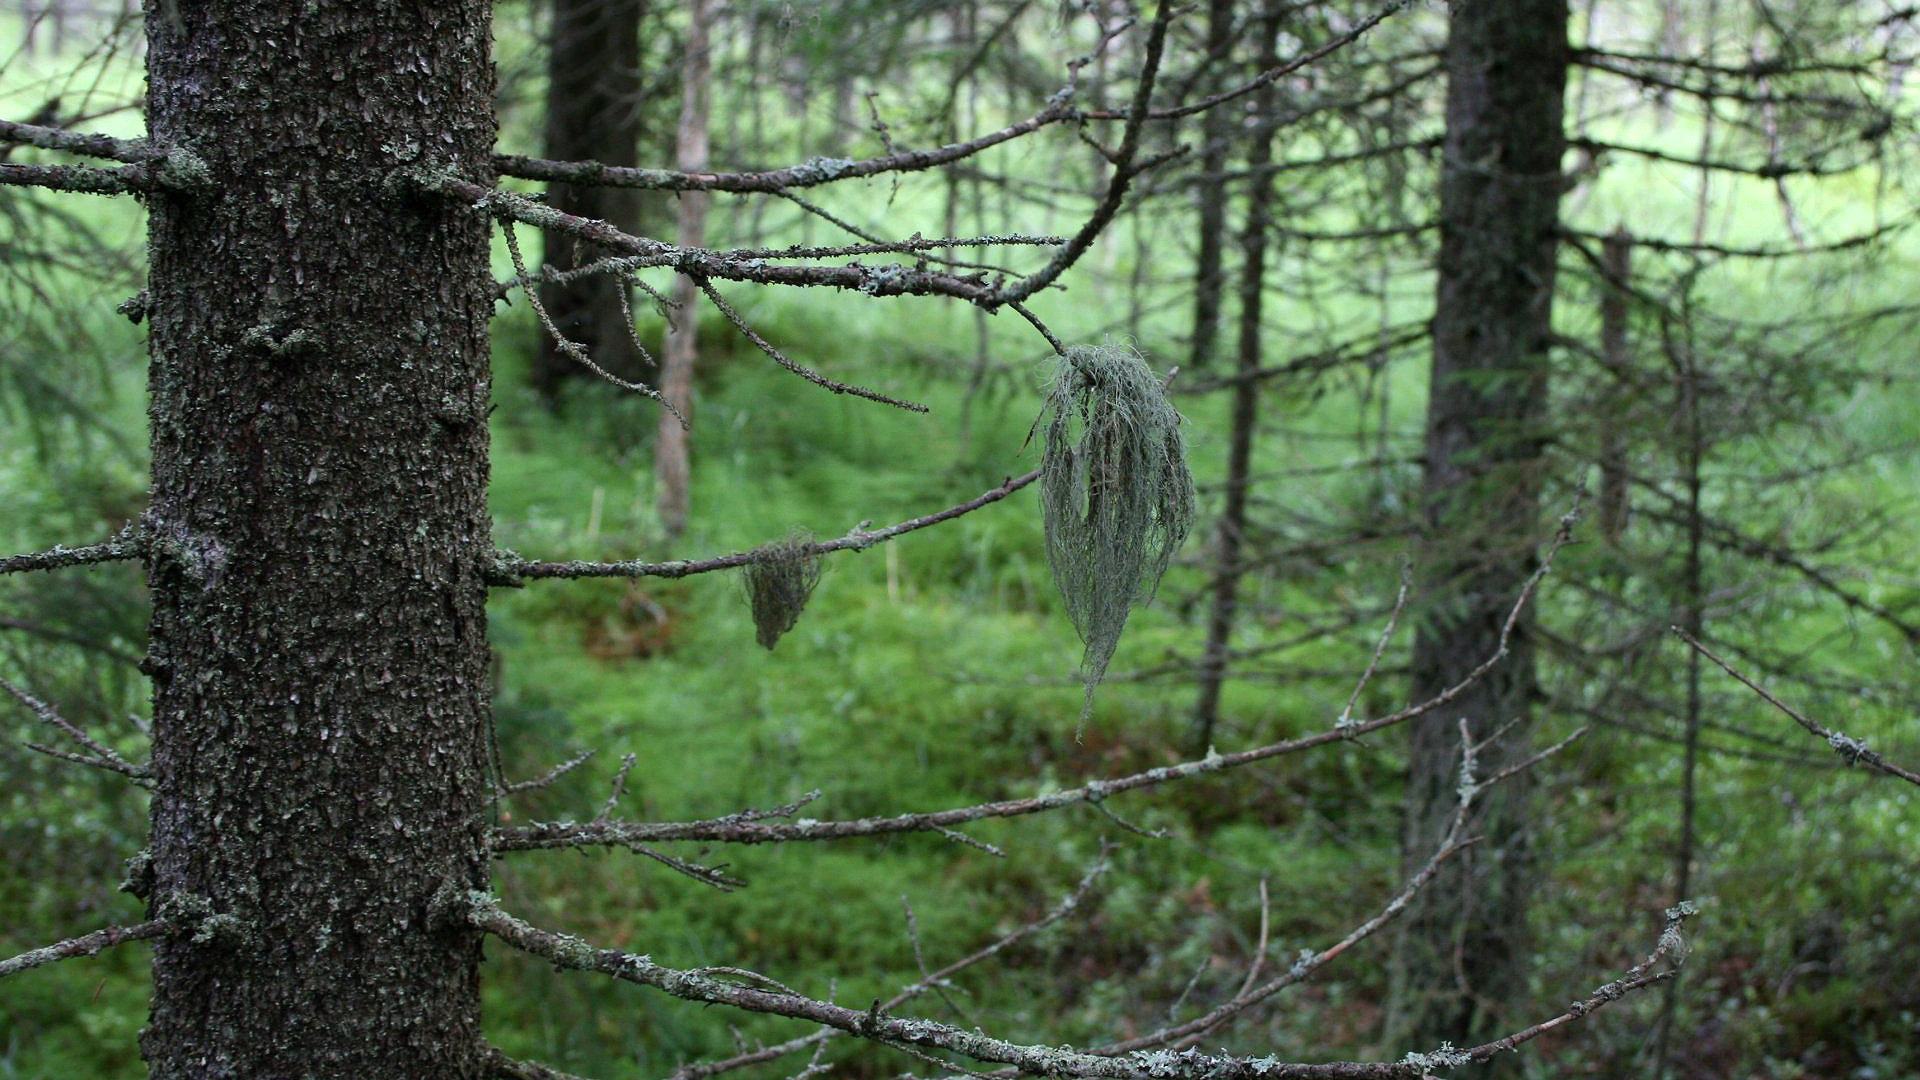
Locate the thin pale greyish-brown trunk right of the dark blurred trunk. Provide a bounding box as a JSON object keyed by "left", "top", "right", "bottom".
{"left": 653, "top": 0, "right": 712, "bottom": 536}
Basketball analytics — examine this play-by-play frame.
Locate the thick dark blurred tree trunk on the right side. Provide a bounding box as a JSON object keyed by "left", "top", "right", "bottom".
{"left": 1388, "top": 0, "right": 1569, "bottom": 1074}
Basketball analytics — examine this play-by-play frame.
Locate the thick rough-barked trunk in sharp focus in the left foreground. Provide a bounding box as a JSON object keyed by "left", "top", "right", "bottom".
{"left": 142, "top": 0, "right": 493, "bottom": 1080}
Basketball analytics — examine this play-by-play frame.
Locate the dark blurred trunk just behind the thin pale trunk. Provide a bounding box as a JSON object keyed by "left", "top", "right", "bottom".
{"left": 532, "top": 0, "right": 647, "bottom": 396}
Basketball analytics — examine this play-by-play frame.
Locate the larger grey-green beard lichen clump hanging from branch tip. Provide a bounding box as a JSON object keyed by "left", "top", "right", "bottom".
{"left": 1041, "top": 346, "right": 1194, "bottom": 738}
